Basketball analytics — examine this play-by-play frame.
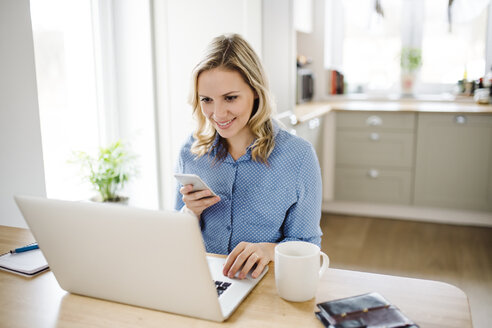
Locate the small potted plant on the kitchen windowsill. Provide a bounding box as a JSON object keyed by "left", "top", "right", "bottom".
{"left": 400, "top": 47, "right": 422, "bottom": 95}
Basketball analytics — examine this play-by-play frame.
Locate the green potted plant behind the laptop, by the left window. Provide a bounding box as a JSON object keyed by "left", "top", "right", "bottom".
{"left": 74, "top": 140, "right": 136, "bottom": 204}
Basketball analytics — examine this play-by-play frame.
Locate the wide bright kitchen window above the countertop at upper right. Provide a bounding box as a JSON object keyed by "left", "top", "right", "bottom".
{"left": 325, "top": 0, "right": 489, "bottom": 93}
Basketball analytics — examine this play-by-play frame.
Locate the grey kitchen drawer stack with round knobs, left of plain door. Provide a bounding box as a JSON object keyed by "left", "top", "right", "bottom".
{"left": 335, "top": 111, "right": 416, "bottom": 205}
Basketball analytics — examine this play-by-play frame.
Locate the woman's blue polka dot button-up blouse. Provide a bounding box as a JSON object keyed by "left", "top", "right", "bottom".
{"left": 175, "top": 124, "right": 322, "bottom": 254}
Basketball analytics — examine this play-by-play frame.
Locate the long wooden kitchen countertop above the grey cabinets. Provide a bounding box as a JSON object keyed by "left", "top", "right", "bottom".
{"left": 294, "top": 99, "right": 492, "bottom": 123}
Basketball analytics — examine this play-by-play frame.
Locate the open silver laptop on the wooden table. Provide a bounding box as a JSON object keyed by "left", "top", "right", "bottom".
{"left": 15, "top": 196, "right": 268, "bottom": 321}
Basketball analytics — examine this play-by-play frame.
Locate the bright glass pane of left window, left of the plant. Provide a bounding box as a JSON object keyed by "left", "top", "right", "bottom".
{"left": 31, "top": 0, "right": 99, "bottom": 200}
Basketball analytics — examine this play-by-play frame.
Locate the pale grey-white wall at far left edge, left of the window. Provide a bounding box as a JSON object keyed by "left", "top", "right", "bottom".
{"left": 0, "top": 0, "right": 46, "bottom": 227}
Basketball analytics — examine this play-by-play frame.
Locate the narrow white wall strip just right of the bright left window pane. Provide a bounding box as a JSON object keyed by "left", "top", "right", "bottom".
{"left": 112, "top": 0, "right": 159, "bottom": 209}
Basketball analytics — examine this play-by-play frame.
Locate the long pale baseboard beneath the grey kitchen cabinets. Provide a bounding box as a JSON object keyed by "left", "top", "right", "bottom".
{"left": 322, "top": 201, "right": 492, "bottom": 227}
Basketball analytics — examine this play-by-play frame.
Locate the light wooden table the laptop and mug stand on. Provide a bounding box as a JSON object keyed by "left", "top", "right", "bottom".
{"left": 0, "top": 226, "right": 472, "bottom": 327}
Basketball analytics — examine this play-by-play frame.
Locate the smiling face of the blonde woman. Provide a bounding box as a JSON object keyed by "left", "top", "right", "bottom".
{"left": 198, "top": 68, "right": 255, "bottom": 144}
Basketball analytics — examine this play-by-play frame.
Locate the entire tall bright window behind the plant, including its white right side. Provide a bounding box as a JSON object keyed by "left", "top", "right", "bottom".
{"left": 31, "top": 0, "right": 159, "bottom": 208}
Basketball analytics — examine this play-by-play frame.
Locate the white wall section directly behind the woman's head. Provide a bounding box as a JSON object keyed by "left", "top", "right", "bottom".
{"left": 153, "top": 0, "right": 262, "bottom": 208}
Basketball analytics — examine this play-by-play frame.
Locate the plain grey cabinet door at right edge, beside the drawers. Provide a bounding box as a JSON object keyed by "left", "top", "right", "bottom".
{"left": 414, "top": 113, "right": 492, "bottom": 211}
